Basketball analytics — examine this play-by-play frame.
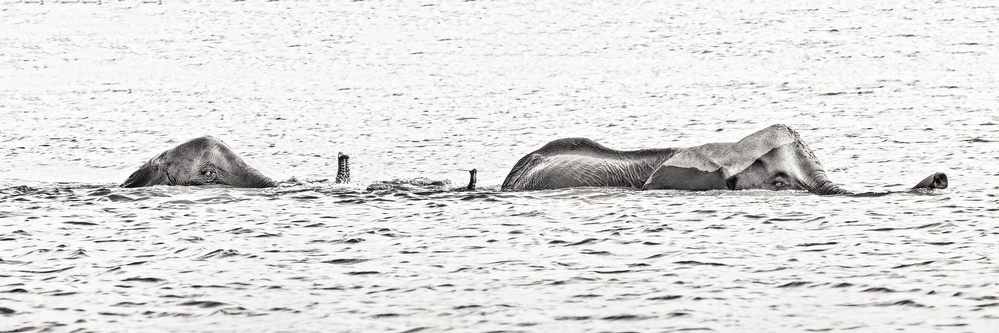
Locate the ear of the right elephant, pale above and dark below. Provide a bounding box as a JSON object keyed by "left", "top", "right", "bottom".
{"left": 642, "top": 150, "right": 729, "bottom": 191}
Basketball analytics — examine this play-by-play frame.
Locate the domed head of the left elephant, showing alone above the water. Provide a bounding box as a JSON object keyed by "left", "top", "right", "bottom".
{"left": 121, "top": 136, "right": 278, "bottom": 187}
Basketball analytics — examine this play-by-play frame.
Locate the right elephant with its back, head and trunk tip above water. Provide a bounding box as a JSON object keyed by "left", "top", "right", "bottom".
{"left": 502, "top": 124, "right": 947, "bottom": 194}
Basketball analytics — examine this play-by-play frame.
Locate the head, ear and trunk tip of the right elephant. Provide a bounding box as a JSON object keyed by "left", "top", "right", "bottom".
{"left": 643, "top": 124, "right": 947, "bottom": 194}
